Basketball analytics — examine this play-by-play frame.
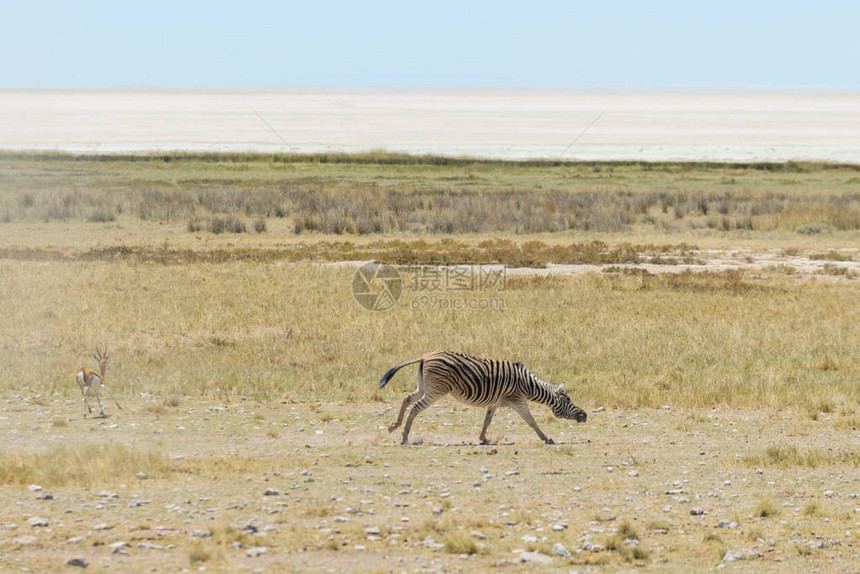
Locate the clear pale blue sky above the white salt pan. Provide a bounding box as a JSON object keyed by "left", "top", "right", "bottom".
{"left": 0, "top": 0, "right": 860, "bottom": 89}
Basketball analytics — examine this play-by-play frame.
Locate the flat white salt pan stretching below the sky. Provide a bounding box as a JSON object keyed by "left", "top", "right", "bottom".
{"left": 0, "top": 89, "right": 860, "bottom": 163}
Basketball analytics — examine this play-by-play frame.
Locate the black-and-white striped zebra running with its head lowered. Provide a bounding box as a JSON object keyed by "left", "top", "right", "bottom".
{"left": 379, "top": 351, "right": 588, "bottom": 444}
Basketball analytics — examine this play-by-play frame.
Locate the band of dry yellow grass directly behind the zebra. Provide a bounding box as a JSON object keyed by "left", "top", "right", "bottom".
{"left": 0, "top": 260, "right": 860, "bottom": 414}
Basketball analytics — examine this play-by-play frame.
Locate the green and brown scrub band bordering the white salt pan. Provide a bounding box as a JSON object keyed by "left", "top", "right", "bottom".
{"left": 0, "top": 153, "right": 860, "bottom": 235}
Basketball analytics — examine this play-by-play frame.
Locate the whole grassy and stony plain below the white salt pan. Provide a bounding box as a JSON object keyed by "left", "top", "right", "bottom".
{"left": 0, "top": 152, "right": 860, "bottom": 572}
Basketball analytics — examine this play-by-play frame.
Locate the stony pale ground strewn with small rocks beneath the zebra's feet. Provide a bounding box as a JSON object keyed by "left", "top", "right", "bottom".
{"left": 0, "top": 395, "right": 860, "bottom": 572}
